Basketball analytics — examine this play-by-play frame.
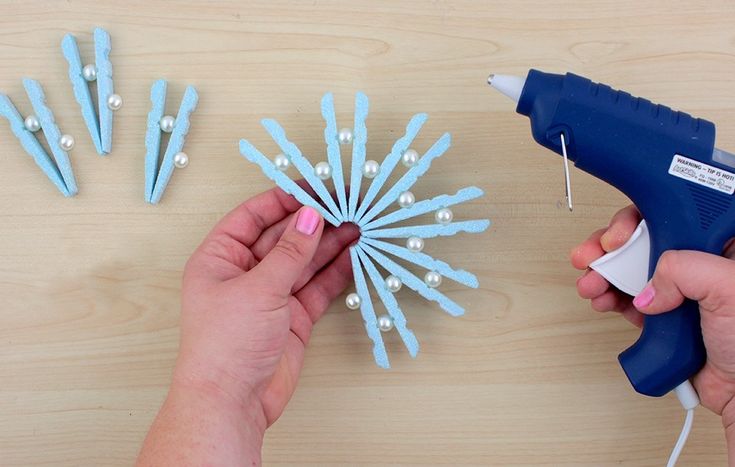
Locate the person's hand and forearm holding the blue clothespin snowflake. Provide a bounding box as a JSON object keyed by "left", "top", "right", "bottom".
{"left": 138, "top": 189, "right": 359, "bottom": 465}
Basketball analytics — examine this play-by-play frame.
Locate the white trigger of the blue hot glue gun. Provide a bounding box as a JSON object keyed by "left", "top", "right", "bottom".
{"left": 590, "top": 221, "right": 651, "bottom": 297}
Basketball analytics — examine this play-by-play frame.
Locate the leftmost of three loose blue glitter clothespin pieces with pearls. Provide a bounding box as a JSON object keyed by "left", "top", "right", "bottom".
{"left": 0, "top": 78, "right": 77, "bottom": 196}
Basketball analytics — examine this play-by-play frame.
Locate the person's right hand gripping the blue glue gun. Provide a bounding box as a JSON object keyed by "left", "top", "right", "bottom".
{"left": 571, "top": 206, "right": 735, "bottom": 466}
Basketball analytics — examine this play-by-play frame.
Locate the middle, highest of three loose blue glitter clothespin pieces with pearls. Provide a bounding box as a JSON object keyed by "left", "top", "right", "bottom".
{"left": 61, "top": 28, "right": 122, "bottom": 156}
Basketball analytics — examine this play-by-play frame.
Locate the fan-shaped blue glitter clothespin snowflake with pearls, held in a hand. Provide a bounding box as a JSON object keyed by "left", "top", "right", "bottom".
{"left": 240, "top": 93, "right": 490, "bottom": 368}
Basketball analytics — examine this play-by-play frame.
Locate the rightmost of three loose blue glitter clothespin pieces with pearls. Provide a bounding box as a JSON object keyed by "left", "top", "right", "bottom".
{"left": 145, "top": 79, "right": 199, "bottom": 204}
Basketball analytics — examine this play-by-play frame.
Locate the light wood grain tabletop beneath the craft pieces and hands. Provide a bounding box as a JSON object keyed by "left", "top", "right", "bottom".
{"left": 0, "top": 0, "right": 735, "bottom": 466}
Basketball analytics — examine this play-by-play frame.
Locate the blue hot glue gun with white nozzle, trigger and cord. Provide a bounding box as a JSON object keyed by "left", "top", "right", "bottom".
{"left": 488, "top": 70, "right": 735, "bottom": 465}
